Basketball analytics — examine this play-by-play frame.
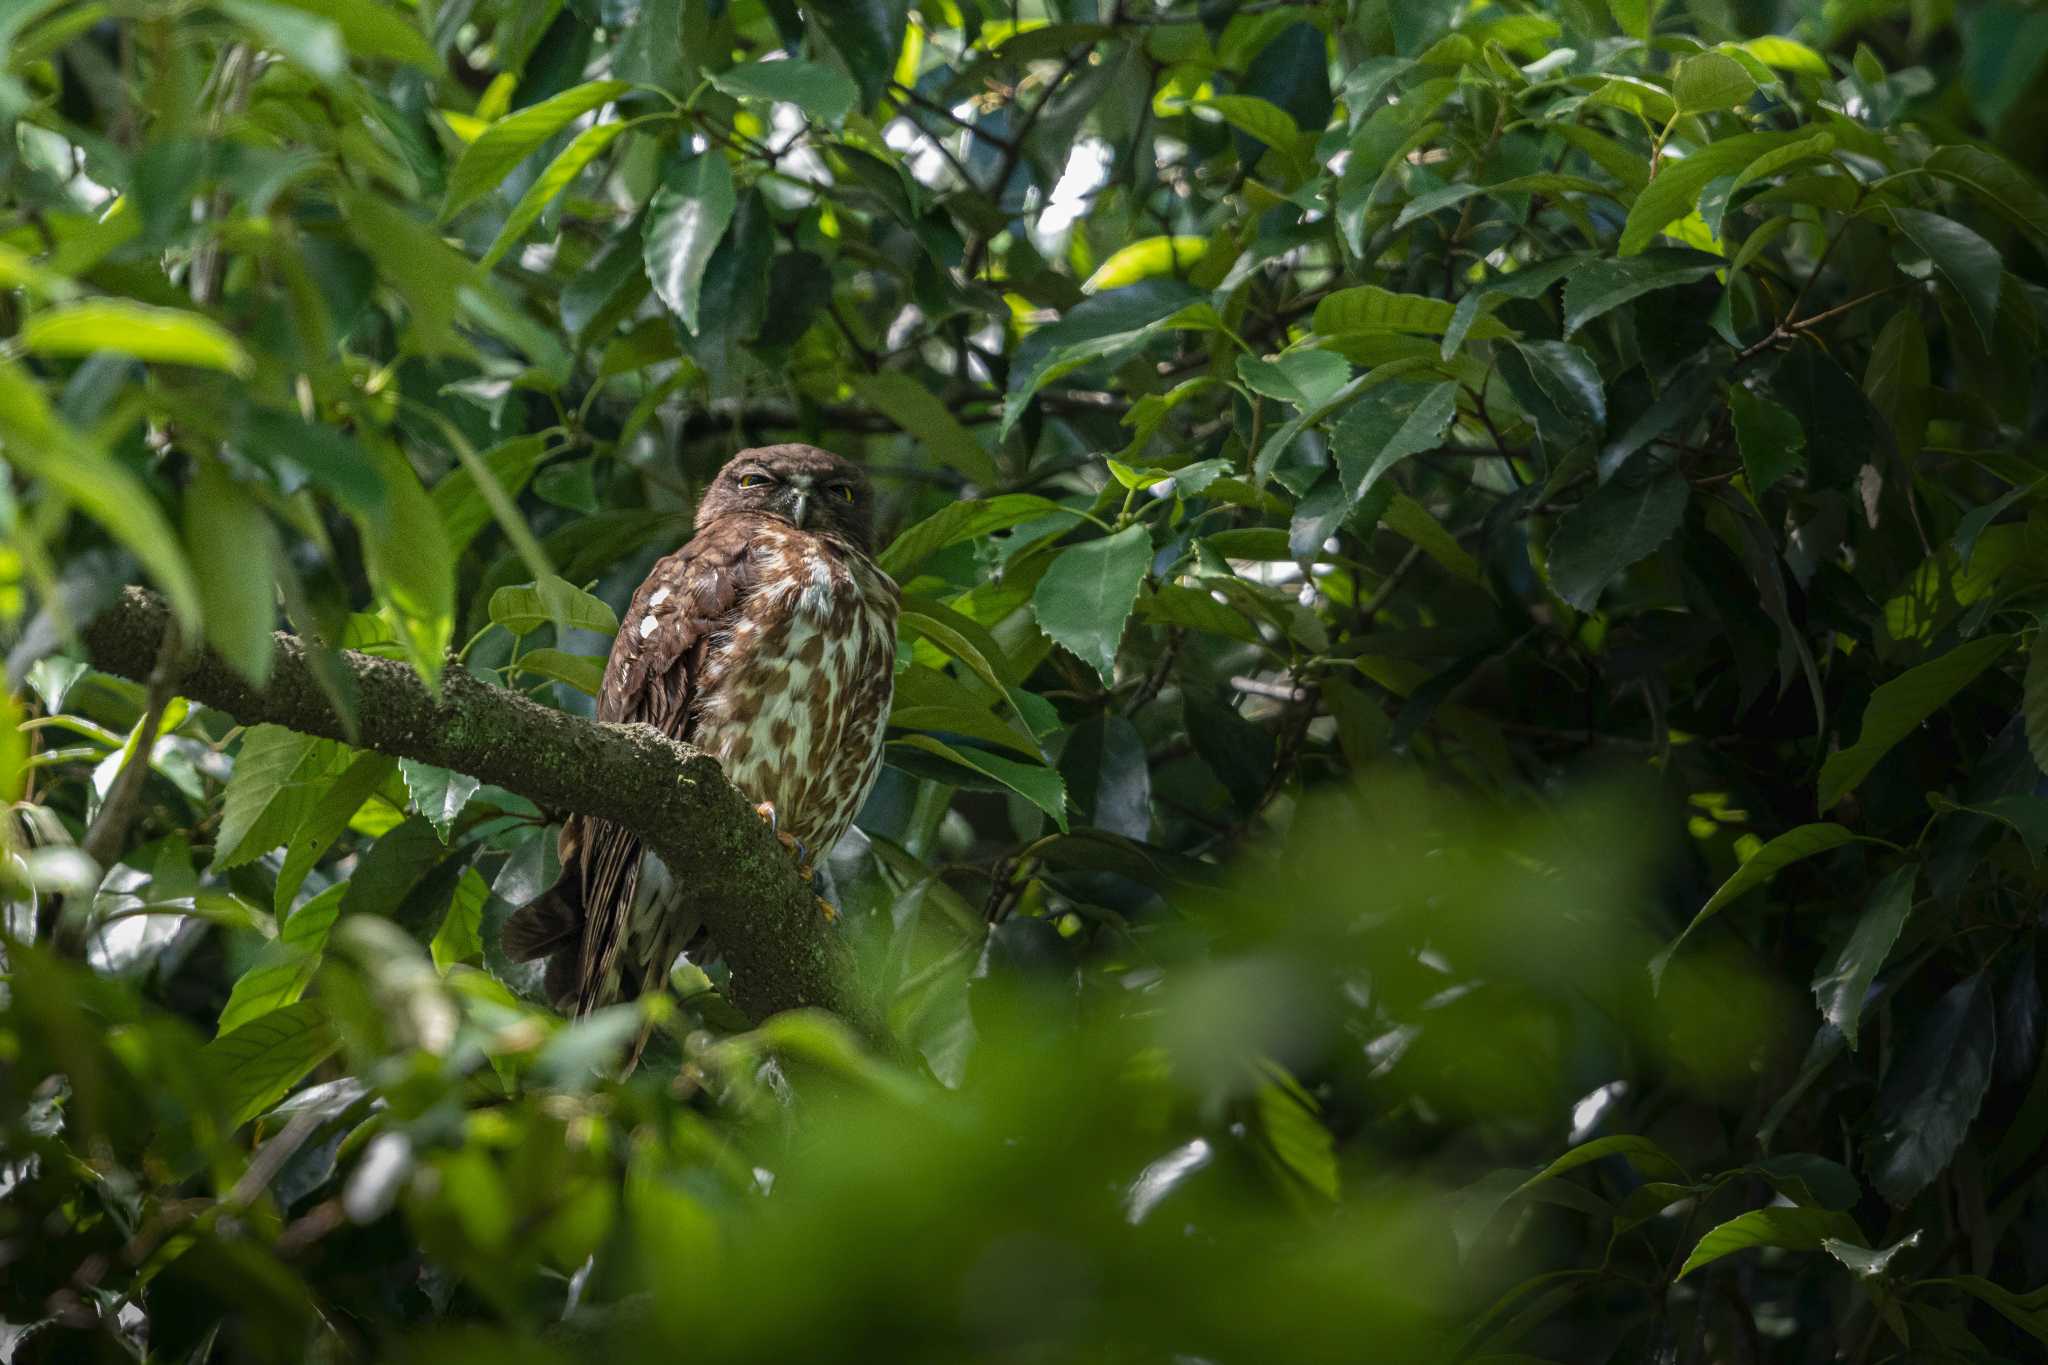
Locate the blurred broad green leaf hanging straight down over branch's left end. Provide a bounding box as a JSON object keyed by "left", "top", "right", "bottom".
{"left": 184, "top": 458, "right": 281, "bottom": 688}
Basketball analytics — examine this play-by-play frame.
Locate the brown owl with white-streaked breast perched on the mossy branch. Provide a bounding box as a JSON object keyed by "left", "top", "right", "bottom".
{"left": 504, "top": 444, "right": 897, "bottom": 1015}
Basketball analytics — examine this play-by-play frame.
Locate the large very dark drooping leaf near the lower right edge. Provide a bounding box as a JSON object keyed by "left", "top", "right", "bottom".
{"left": 1853, "top": 972, "right": 1997, "bottom": 1203}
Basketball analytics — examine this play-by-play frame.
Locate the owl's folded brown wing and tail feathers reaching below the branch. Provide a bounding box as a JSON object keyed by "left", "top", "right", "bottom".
{"left": 504, "top": 518, "right": 754, "bottom": 1015}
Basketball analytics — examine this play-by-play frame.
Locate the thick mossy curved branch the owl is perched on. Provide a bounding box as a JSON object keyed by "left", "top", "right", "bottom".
{"left": 84, "top": 587, "right": 852, "bottom": 1019}
